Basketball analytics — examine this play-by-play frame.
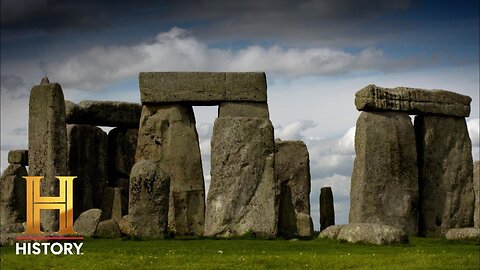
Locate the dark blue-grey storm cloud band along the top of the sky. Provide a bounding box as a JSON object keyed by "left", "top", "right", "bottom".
{"left": 1, "top": 0, "right": 412, "bottom": 43}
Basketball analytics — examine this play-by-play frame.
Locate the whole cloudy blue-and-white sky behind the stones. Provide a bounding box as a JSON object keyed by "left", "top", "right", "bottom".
{"left": 0, "top": 0, "right": 480, "bottom": 230}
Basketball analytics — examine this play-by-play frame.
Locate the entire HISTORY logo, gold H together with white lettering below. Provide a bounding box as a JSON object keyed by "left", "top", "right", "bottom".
{"left": 15, "top": 176, "right": 83, "bottom": 255}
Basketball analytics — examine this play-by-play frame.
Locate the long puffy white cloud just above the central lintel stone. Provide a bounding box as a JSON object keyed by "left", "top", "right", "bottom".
{"left": 42, "top": 28, "right": 383, "bottom": 90}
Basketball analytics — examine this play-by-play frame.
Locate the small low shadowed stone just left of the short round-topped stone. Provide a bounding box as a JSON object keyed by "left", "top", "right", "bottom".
{"left": 102, "top": 187, "right": 128, "bottom": 222}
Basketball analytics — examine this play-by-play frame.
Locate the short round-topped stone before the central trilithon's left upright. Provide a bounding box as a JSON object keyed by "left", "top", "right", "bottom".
{"left": 128, "top": 160, "right": 170, "bottom": 239}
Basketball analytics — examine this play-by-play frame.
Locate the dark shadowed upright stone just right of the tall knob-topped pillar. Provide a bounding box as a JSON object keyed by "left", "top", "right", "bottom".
{"left": 67, "top": 125, "right": 107, "bottom": 219}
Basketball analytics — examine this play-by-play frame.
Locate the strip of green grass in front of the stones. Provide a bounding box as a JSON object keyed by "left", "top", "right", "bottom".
{"left": 0, "top": 238, "right": 480, "bottom": 270}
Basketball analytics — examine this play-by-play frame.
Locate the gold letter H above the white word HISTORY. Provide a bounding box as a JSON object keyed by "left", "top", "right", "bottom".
{"left": 23, "top": 176, "right": 77, "bottom": 234}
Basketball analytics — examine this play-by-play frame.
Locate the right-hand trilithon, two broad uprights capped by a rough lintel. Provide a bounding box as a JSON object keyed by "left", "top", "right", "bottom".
{"left": 349, "top": 85, "right": 474, "bottom": 236}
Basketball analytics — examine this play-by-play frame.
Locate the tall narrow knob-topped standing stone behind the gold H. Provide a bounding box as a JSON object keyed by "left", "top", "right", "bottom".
{"left": 28, "top": 80, "right": 68, "bottom": 232}
